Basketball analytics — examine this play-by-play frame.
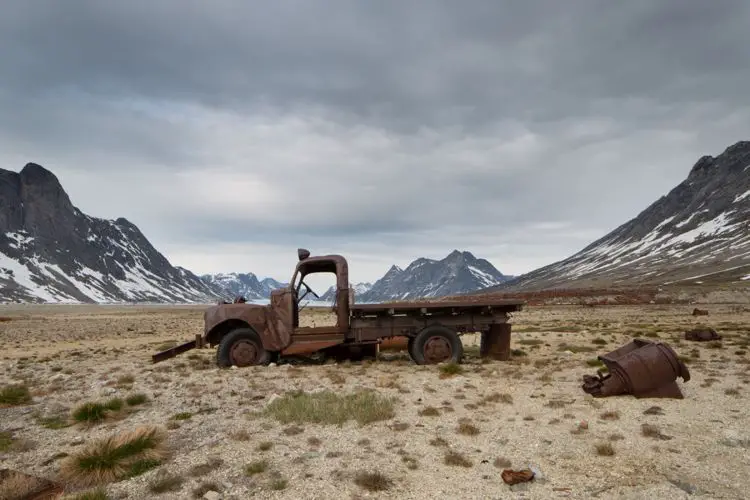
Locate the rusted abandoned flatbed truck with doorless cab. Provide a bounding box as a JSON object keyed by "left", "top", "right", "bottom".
{"left": 152, "top": 252, "right": 525, "bottom": 367}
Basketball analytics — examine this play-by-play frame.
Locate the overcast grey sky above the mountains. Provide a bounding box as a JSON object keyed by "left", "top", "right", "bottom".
{"left": 0, "top": 0, "right": 750, "bottom": 281}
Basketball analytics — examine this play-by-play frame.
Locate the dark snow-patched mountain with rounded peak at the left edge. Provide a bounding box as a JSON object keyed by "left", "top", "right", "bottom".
{"left": 0, "top": 163, "right": 224, "bottom": 303}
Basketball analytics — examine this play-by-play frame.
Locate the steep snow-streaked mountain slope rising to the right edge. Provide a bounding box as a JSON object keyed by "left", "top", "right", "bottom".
{"left": 483, "top": 141, "right": 750, "bottom": 292}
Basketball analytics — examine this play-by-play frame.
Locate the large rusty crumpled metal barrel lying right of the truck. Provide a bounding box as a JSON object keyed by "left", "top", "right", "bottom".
{"left": 582, "top": 339, "right": 690, "bottom": 399}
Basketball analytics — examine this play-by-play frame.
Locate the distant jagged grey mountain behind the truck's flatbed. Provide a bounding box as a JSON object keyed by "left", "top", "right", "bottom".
{"left": 355, "top": 250, "right": 511, "bottom": 304}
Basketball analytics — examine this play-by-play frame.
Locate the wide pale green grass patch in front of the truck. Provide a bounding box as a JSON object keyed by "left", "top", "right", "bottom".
{"left": 264, "top": 390, "right": 395, "bottom": 425}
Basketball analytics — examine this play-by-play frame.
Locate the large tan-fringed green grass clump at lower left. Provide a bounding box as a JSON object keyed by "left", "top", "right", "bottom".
{"left": 60, "top": 426, "right": 168, "bottom": 486}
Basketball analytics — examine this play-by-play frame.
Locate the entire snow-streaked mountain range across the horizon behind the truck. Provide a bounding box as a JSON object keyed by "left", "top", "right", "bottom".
{"left": 0, "top": 141, "right": 750, "bottom": 303}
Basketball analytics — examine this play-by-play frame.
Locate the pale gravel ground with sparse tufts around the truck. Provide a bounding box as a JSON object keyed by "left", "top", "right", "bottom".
{"left": 0, "top": 304, "right": 750, "bottom": 499}
